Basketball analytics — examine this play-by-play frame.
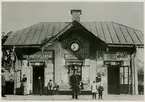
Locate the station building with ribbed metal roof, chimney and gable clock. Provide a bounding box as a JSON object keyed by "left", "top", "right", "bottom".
{"left": 3, "top": 10, "right": 144, "bottom": 94}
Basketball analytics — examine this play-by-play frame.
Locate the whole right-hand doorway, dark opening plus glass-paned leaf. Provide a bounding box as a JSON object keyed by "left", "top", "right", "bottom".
{"left": 108, "top": 66, "right": 132, "bottom": 94}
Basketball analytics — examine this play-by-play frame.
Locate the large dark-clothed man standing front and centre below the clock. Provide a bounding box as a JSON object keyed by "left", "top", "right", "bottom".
{"left": 70, "top": 70, "right": 80, "bottom": 99}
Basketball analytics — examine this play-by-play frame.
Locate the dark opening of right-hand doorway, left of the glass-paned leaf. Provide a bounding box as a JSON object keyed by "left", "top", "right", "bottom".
{"left": 108, "top": 65, "right": 119, "bottom": 94}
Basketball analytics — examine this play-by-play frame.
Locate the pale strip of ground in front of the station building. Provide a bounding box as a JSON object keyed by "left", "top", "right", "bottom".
{"left": 2, "top": 95, "right": 144, "bottom": 101}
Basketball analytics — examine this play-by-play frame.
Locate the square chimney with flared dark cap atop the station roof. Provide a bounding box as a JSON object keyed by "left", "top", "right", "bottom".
{"left": 71, "top": 9, "right": 82, "bottom": 22}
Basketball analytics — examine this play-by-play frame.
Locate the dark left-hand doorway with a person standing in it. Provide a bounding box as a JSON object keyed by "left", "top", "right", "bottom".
{"left": 33, "top": 66, "right": 44, "bottom": 94}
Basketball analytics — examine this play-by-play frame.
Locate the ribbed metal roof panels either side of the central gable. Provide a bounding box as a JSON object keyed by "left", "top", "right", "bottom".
{"left": 4, "top": 21, "right": 144, "bottom": 46}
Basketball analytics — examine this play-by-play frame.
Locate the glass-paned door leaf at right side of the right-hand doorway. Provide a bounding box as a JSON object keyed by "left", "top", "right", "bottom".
{"left": 120, "top": 66, "right": 131, "bottom": 94}
